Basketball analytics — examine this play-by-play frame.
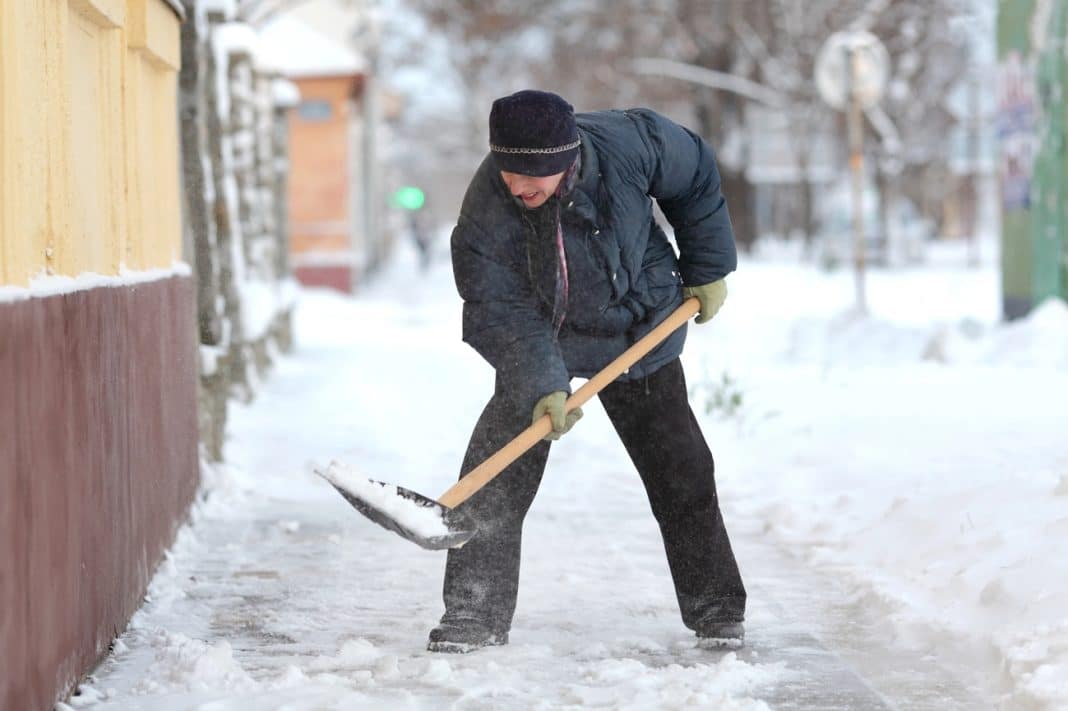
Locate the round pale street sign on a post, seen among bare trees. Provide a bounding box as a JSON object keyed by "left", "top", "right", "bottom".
{"left": 816, "top": 30, "right": 890, "bottom": 110}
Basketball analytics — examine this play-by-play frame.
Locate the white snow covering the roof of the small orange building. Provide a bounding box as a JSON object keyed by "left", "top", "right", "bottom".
{"left": 258, "top": 16, "right": 367, "bottom": 77}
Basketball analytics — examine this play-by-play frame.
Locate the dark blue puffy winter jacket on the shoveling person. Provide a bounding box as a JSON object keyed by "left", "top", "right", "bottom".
{"left": 452, "top": 104, "right": 737, "bottom": 407}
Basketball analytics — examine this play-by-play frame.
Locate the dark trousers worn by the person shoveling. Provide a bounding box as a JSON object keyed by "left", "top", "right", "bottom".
{"left": 443, "top": 359, "right": 745, "bottom": 632}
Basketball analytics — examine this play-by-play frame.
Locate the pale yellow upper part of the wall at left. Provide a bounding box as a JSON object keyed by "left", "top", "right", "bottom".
{"left": 0, "top": 0, "right": 182, "bottom": 286}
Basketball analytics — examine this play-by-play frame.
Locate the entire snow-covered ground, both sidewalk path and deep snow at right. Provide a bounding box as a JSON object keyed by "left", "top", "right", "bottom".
{"left": 72, "top": 241, "right": 1068, "bottom": 711}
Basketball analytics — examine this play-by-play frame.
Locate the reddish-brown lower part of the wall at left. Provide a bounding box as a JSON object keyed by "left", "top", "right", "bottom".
{"left": 0, "top": 277, "right": 199, "bottom": 711}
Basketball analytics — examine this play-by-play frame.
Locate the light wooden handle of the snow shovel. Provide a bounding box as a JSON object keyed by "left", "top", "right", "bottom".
{"left": 438, "top": 297, "right": 701, "bottom": 508}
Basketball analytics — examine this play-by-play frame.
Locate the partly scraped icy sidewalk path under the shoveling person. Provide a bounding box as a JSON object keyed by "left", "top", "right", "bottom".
{"left": 73, "top": 255, "right": 983, "bottom": 711}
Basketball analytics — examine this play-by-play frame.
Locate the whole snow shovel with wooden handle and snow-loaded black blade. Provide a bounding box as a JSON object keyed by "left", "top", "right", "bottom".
{"left": 315, "top": 297, "right": 701, "bottom": 551}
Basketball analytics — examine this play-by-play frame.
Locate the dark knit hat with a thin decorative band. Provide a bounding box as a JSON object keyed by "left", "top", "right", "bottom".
{"left": 489, "top": 90, "right": 580, "bottom": 177}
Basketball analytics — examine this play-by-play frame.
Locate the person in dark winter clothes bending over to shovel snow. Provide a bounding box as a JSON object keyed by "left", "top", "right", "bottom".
{"left": 428, "top": 91, "right": 745, "bottom": 651}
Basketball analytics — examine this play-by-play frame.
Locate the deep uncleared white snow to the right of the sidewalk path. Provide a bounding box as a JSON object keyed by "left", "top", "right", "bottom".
{"left": 700, "top": 257, "right": 1068, "bottom": 708}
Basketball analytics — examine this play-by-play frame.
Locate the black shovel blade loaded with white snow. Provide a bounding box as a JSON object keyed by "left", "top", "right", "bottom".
{"left": 315, "top": 461, "right": 477, "bottom": 551}
